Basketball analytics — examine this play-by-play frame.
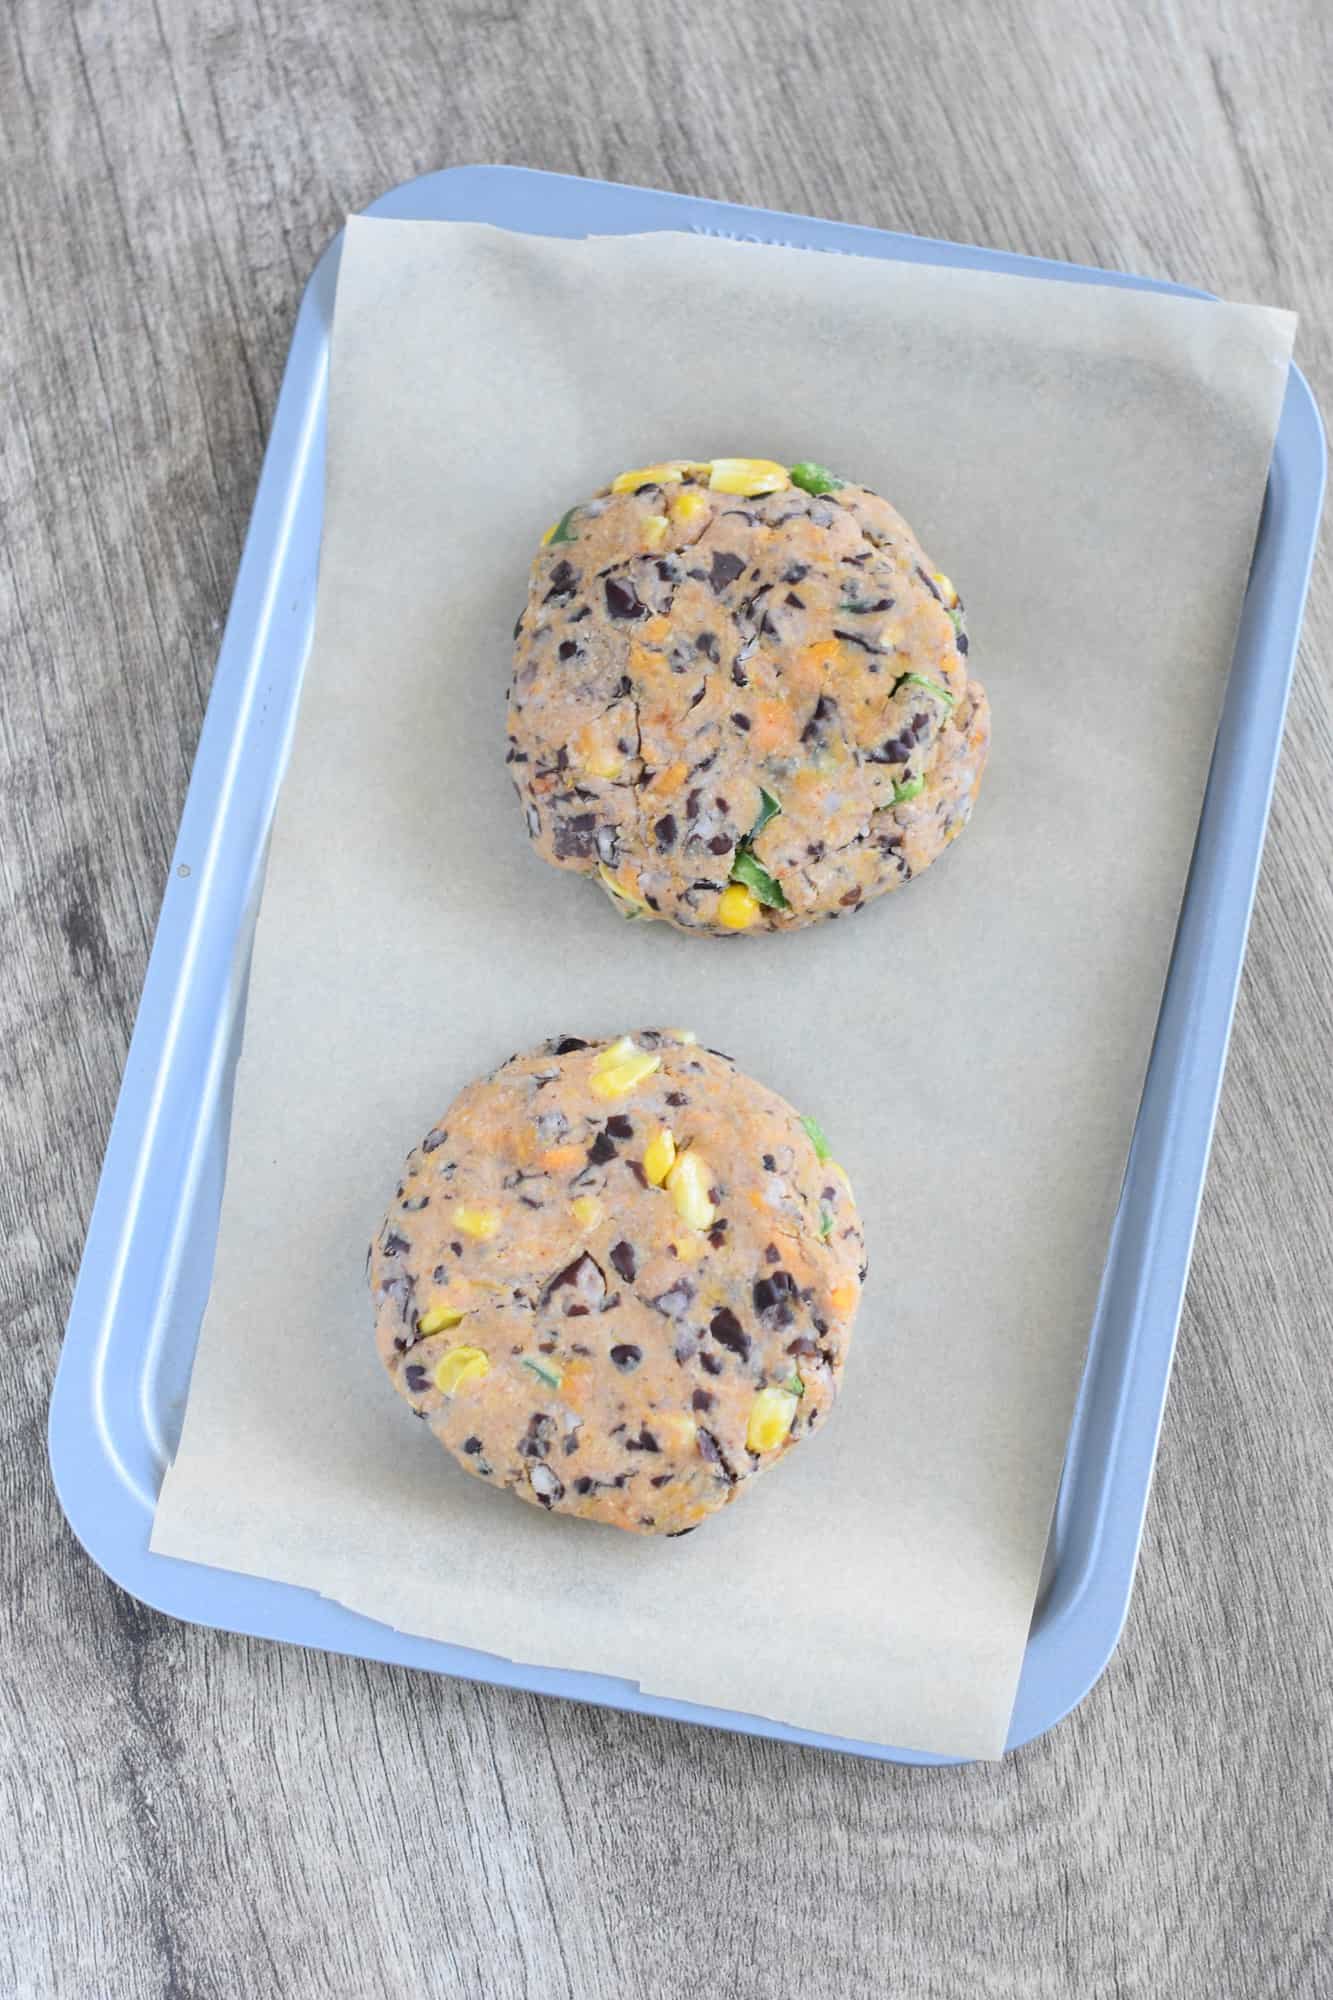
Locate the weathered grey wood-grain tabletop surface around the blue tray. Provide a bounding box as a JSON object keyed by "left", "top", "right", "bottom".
{"left": 0, "top": 0, "right": 1333, "bottom": 2000}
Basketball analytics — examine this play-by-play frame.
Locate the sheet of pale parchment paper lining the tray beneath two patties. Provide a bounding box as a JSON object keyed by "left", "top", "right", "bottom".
{"left": 152, "top": 220, "right": 1293, "bottom": 1756}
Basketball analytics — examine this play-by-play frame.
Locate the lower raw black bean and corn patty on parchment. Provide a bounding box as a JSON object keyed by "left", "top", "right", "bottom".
{"left": 368, "top": 1030, "right": 865, "bottom": 1534}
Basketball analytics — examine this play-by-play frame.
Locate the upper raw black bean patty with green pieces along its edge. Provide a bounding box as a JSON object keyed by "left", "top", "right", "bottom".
{"left": 508, "top": 458, "right": 991, "bottom": 936}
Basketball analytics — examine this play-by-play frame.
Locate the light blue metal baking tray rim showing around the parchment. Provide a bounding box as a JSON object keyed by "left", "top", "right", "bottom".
{"left": 50, "top": 166, "right": 1325, "bottom": 1764}
